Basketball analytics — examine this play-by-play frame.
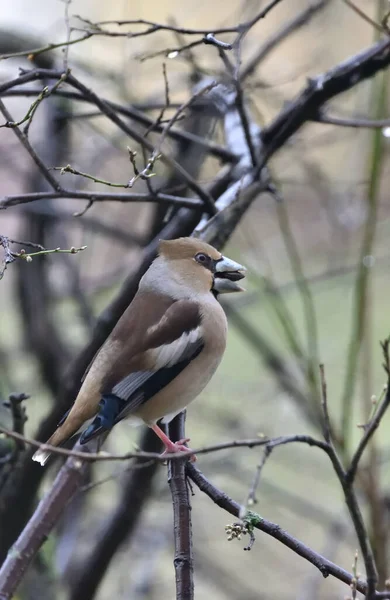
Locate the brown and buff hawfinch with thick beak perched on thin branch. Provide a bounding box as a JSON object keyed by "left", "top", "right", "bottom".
{"left": 33, "top": 237, "right": 246, "bottom": 466}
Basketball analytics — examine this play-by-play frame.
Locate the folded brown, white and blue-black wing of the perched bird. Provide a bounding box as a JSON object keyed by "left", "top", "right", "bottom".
{"left": 81, "top": 300, "right": 204, "bottom": 443}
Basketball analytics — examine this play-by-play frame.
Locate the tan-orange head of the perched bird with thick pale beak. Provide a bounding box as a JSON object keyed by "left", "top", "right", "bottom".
{"left": 159, "top": 238, "right": 246, "bottom": 295}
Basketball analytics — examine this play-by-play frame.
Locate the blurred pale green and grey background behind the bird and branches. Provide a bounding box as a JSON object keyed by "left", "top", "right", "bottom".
{"left": 0, "top": 0, "right": 390, "bottom": 600}
